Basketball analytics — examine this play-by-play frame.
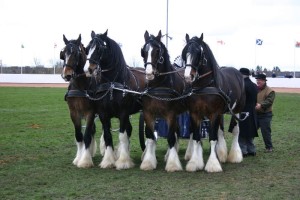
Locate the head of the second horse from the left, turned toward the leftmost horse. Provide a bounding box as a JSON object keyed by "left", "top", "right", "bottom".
{"left": 84, "top": 30, "right": 108, "bottom": 75}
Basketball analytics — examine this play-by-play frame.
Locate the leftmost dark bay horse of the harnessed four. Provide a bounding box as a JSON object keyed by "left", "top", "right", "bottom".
{"left": 60, "top": 35, "right": 97, "bottom": 168}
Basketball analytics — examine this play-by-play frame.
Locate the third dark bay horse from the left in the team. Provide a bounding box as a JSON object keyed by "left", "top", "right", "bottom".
{"left": 140, "top": 31, "right": 186, "bottom": 172}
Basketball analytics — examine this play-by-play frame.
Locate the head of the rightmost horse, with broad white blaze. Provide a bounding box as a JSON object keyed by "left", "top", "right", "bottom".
{"left": 181, "top": 33, "right": 209, "bottom": 82}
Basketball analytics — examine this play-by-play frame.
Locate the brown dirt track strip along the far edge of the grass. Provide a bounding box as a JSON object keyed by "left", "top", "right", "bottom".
{"left": 0, "top": 83, "right": 300, "bottom": 94}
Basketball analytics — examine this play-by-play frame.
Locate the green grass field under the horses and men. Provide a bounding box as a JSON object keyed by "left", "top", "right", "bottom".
{"left": 0, "top": 87, "right": 300, "bottom": 199}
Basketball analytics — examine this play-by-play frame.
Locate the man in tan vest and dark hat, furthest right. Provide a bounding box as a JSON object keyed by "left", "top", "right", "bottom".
{"left": 255, "top": 74, "right": 275, "bottom": 152}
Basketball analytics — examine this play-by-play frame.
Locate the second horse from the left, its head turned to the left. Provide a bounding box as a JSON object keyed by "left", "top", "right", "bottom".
{"left": 85, "top": 31, "right": 146, "bottom": 169}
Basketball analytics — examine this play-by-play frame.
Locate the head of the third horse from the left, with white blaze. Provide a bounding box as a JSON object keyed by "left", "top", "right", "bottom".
{"left": 141, "top": 31, "right": 169, "bottom": 80}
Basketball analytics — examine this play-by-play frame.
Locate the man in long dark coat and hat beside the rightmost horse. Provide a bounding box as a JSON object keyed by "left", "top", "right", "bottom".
{"left": 239, "top": 68, "right": 258, "bottom": 157}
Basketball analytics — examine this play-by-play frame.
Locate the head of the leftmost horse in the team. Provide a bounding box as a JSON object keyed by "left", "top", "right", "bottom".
{"left": 60, "top": 34, "right": 86, "bottom": 81}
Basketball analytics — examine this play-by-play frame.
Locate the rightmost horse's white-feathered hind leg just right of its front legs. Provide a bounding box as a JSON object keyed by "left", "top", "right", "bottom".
{"left": 216, "top": 115, "right": 228, "bottom": 163}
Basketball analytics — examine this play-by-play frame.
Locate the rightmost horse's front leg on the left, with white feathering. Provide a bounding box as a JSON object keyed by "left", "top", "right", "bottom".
{"left": 185, "top": 117, "right": 204, "bottom": 172}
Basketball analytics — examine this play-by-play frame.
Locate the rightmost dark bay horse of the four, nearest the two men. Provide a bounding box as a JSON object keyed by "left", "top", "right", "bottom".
{"left": 182, "top": 34, "right": 245, "bottom": 172}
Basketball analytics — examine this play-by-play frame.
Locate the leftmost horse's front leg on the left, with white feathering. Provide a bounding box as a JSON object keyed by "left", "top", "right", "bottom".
{"left": 71, "top": 112, "right": 84, "bottom": 166}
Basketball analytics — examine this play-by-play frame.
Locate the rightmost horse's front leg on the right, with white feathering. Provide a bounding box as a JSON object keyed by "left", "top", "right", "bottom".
{"left": 205, "top": 115, "right": 222, "bottom": 172}
